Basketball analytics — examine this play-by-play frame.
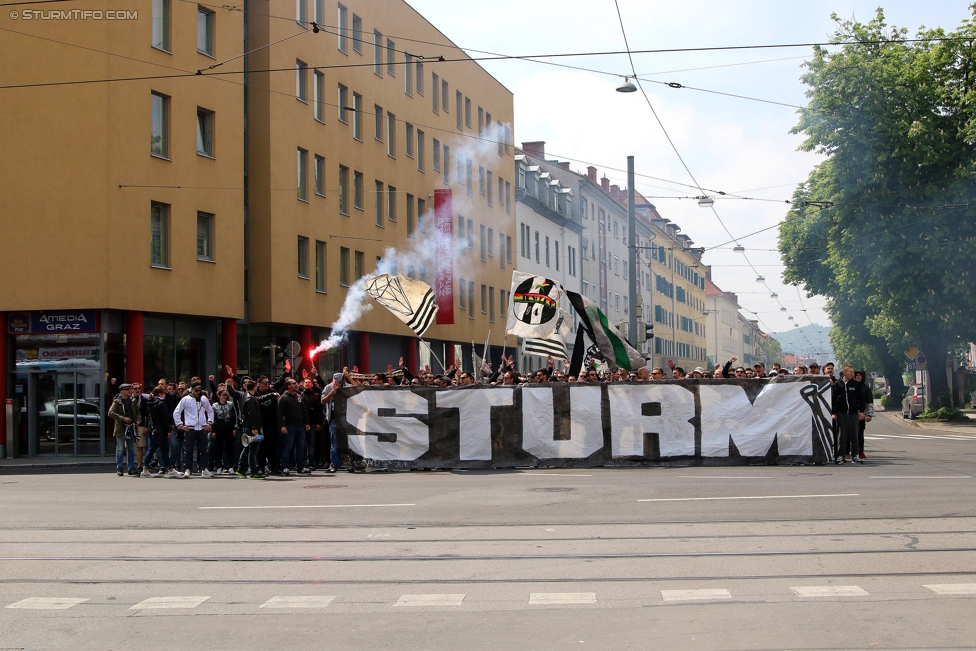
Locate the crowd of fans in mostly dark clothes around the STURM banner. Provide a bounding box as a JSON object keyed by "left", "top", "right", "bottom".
{"left": 109, "top": 356, "right": 874, "bottom": 479}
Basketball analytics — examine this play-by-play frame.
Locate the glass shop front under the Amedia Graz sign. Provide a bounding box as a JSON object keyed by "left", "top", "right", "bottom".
{"left": 6, "top": 310, "right": 105, "bottom": 457}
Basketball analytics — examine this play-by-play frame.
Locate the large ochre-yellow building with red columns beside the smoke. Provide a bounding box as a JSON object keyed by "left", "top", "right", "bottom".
{"left": 0, "top": 0, "right": 514, "bottom": 456}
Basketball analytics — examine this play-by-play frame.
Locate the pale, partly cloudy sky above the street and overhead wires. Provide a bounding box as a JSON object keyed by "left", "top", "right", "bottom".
{"left": 407, "top": 0, "right": 970, "bottom": 348}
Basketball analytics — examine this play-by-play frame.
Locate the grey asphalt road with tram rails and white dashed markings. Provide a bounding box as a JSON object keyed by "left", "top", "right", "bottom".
{"left": 0, "top": 416, "right": 976, "bottom": 651}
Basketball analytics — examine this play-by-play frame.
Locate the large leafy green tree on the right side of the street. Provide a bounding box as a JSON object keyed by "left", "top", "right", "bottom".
{"left": 779, "top": 5, "right": 976, "bottom": 408}
